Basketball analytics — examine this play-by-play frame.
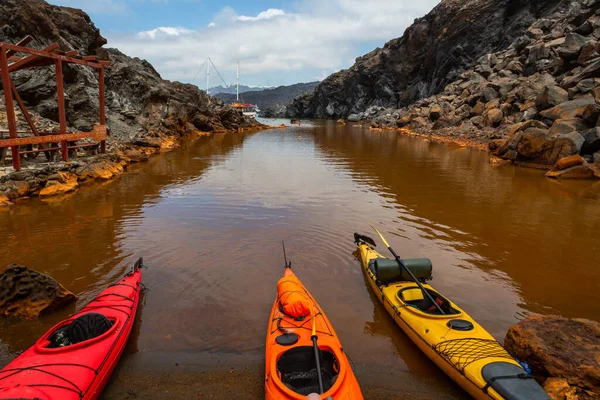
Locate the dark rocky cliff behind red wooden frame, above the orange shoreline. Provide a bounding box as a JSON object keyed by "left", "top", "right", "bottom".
{"left": 0, "top": 0, "right": 256, "bottom": 140}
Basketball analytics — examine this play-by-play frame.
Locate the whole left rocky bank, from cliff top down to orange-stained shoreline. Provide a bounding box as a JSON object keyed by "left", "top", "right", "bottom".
{"left": 0, "top": 0, "right": 264, "bottom": 200}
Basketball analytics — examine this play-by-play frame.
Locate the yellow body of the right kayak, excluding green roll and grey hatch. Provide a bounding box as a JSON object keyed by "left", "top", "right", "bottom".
{"left": 357, "top": 241, "right": 549, "bottom": 399}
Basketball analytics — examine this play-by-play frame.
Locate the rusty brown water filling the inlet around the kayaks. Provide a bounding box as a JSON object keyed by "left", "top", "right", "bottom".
{"left": 0, "top": 123, "right": 600, "bottom": 399}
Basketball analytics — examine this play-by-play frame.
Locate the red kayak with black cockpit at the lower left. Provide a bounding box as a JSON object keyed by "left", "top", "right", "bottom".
{"left": 0, "top": 258, "right": 142, "bottom": 400}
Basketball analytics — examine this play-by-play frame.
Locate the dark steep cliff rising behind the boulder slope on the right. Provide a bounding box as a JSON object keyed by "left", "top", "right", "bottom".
{"left": 287, "top": 0, "right": 578, "bottom": 118}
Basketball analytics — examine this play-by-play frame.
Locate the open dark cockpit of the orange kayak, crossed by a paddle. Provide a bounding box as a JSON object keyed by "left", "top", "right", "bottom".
{"left": 277, "top": 346, "right": 339, "bottom": 396}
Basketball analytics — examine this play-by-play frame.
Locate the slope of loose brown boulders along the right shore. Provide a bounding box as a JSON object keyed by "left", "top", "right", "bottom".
{"left": 302, "top": 0, "right": 600, "bottom": 179}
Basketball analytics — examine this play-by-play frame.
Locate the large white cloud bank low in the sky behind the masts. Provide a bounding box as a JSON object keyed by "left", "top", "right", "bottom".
{"left": 105, "top": 0, "right": 439, "bottom": 85}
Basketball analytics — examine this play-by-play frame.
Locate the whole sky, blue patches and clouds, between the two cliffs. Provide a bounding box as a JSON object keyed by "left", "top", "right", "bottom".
{"left": 49, "top": 0, "right": 439, "bottom": 88}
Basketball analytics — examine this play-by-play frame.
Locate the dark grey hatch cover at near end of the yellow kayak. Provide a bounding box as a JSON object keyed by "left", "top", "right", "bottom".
{"left": 481, "top": 361, "right": 550, "bottom": 400}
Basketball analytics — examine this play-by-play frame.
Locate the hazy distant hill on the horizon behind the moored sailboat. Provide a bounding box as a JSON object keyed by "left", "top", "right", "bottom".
{"left": 214, "top": 82, "right": 319, "bottom": 113}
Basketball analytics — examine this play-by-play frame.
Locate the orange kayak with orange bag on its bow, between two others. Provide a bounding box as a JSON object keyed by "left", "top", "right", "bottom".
{"left": 265, "top": 267, "right": 363, "bottom": 400}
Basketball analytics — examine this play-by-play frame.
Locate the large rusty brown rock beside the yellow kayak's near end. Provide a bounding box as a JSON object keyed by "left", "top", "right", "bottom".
{"left": 504, "top": 315, "right": 600, "bottom": 400}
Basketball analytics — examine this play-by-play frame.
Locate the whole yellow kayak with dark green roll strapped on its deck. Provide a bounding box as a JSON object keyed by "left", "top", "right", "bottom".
{"left": 354, "top": 233, "right": 550, "bottom": 400}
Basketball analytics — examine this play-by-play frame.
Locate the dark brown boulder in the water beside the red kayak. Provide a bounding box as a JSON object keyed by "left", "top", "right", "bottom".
{"left": 0, "top": 264, "right": 77, "bottom": 318}
